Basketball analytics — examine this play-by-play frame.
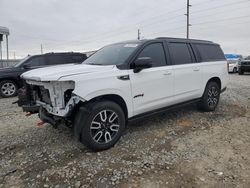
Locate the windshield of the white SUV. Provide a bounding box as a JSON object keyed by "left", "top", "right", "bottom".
{"left": 84, "top": 43, "right": 139, "bottom": 65}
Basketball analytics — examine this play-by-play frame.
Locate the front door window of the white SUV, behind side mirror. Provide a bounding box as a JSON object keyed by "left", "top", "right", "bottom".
{"left": 137, "top": 43, "right": 166, "bottom": 67}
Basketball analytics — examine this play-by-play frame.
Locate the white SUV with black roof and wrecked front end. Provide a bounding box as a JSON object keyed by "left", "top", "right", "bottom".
{"left": 18, "top": 38, "right": 228, "bottom": 150}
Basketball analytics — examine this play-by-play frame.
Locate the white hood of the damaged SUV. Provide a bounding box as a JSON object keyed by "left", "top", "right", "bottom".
{"left": 21, "top": 64, "right": 114, "bottom": 81}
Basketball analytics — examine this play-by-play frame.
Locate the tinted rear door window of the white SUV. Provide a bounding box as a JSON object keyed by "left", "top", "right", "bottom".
{"left": 169, "top": 43, "right": 193, "bottom": 65}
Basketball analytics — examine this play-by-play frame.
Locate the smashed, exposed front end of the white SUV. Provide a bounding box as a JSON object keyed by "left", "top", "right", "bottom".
{"left": 17, "top": 80, "right": 84, "bottom": 125}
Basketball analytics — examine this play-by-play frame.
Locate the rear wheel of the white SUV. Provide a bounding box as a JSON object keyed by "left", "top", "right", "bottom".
{"left": 198, "top": 82, "right": 220, "bottom": 112}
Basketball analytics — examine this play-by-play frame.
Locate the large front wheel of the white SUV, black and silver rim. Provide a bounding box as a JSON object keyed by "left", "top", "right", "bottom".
{"left": 74, "top": 101, "right": 125, "bottom": 151}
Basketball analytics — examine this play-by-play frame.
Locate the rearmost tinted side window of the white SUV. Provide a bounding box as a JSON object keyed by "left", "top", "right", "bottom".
{"left": 195, "top": 44, "right": 225, "bottom": 61}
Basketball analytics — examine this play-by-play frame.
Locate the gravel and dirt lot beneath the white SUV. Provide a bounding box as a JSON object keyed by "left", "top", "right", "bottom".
{"left": 0, "top": 75, "right": 250, "bottom": 188}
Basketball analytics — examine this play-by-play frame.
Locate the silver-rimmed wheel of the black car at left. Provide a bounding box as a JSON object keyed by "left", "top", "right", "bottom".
{"left": 0, "top": 80, "right": 18, "bottom": 98}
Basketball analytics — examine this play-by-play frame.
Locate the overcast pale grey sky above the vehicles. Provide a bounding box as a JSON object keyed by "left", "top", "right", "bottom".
{"left": 0, "top": 0, "right": 250, "bottom": 57}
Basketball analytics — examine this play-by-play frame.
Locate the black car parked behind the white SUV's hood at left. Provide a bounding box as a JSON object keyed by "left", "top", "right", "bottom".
{"left": 0, "top": 52, "right": 87, "bottom": 97}
